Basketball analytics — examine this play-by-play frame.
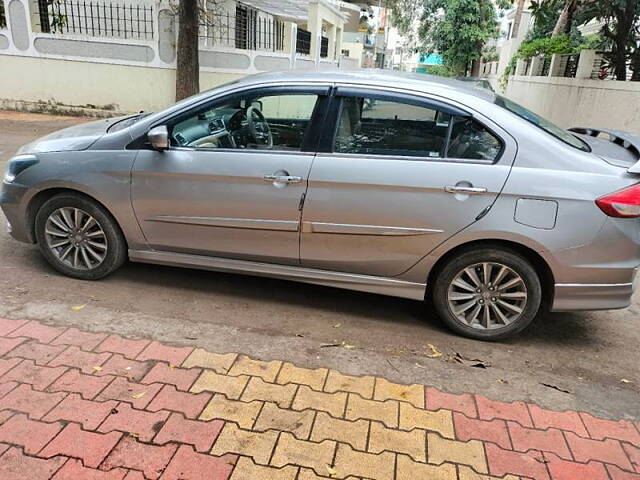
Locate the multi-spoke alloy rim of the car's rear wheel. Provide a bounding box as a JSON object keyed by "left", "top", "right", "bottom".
{"left": 447, "top": 262, "right": 527, "bottom": 330}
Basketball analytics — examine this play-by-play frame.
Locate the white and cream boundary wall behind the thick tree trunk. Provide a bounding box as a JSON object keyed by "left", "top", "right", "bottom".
{"left": 0, "top": 0, "right": 354, "bottom": 112}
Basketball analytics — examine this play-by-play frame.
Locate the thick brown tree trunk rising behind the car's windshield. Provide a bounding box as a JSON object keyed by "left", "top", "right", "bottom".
{"left": 176, "top": 0, "right": 200, "bottom": 101}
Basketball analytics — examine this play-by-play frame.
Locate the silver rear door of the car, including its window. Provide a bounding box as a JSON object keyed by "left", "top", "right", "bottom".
{"left": 300, "top": 86, "right": 516, "bottom": 277}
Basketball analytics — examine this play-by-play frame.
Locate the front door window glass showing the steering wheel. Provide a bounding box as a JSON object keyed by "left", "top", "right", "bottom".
{"left": 170, "top": 90, "right": 318, "bottom": 151}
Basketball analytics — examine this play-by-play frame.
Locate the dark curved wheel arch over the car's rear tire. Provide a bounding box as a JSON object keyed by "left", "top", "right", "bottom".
{"left": 427, "top": 239, "right": 555, "bottom": 308}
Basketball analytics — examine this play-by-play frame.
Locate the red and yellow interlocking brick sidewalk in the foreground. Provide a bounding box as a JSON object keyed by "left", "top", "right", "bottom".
{"left": 0, "top": 318, "right": 640, "bottom": 480}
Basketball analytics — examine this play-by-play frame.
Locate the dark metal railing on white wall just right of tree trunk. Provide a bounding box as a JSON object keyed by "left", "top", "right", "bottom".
{"left": 199, "top": 3, "right": 285, "bottom": 52}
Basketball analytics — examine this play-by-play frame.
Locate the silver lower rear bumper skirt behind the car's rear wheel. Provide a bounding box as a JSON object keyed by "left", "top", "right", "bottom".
{"left": 551, "top": 277, "right": 637, "bottom": 312}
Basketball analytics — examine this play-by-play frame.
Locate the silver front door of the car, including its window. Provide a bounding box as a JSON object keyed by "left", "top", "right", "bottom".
{"left": 132, "top": 86, "right": 329, "bottom": 265}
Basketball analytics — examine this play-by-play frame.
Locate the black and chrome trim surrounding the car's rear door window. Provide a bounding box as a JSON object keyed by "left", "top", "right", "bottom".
{"left": 318, "top": 86, "right": 507, "bottom": 165}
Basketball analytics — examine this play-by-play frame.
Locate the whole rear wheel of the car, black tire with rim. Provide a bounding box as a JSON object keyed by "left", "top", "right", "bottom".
{"left": 431, "top": 247, "right": 542, "bottom": 340}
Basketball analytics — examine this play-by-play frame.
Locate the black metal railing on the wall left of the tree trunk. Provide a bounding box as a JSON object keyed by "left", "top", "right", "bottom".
{"left": 34, "top": 0, "right": 154, "bottom": 39}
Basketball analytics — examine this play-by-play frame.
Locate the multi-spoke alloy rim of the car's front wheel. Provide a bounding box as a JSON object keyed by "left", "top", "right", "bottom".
{"left": 45, "top": 207, "right": 108, "bottom": 270}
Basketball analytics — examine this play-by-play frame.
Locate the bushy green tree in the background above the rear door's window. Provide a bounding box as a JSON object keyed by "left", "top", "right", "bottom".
{"left": 389, "top": 0, "right": 505, "bottom": 75}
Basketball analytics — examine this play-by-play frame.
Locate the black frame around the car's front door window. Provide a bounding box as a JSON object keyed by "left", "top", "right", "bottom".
{"left": 126, "top": 84, "right": 332, "bottom": 154}
